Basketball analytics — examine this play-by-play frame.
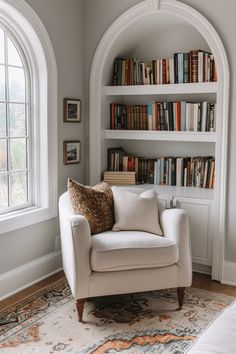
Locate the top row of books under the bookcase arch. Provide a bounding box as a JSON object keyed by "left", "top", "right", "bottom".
{"left": 113, "top": 50, "right": 217, "bottom": 86}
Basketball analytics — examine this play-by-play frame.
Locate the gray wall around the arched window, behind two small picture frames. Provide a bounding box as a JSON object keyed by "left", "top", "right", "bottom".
{"left": 0, "top": 0, "right": 85, "bottom": 274}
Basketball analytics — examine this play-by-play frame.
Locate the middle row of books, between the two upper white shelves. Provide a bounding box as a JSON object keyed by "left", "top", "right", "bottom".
{"left": 110, "top": 101, "right": 216, "bottom": 132}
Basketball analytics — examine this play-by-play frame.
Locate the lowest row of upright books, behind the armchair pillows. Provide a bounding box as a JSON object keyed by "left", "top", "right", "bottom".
{"left": 107, "top": 147, "right": 215, "bottom": 188}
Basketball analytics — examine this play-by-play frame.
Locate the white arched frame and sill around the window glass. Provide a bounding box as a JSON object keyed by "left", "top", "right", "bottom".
{"left": 0, "top": 0, "right": 58, "bottom": 234}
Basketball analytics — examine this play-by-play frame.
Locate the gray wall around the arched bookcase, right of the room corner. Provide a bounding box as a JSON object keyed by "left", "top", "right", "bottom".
{"left": 83, "top": 0, "right": 236, "bottom": 262}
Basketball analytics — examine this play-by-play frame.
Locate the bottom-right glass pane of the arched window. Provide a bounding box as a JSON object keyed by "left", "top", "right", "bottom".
{"left": 10, "top": 172, "right": 28, "bottom": 207}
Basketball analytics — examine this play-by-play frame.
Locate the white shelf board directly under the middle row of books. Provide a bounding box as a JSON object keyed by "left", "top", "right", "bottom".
{"left": 104, "top": 129, "right": 216, "bottom": 143}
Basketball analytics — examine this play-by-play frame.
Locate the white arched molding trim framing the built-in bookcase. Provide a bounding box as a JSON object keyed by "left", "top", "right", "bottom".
{"left": 89, "top": 0, "right": 229, "bottom": 280}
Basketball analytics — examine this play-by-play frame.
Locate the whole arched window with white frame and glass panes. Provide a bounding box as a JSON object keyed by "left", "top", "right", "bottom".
{"left": 0, "top": 0, "right": 58, "bottom": 234}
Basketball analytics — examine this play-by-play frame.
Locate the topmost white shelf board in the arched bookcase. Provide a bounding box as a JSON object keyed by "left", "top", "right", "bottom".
{"left": 104, "top": 82, "right": 218, "bottom": 96}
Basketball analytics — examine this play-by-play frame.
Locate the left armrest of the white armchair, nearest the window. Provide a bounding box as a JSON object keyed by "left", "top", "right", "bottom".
{"left": 59, "top": 192, "right": 92, "bottom": 299}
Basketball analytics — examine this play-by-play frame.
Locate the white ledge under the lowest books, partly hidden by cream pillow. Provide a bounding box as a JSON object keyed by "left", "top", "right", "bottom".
{"left": 119, "top": 184, "right": 214, "bottom": 201}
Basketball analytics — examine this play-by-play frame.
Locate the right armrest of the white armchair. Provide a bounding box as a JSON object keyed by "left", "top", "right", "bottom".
{"left": 160, "top": 209, "right": 192, "bottom": 286}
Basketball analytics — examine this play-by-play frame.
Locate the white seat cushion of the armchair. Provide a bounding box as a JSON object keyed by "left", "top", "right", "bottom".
{"left": 91, "top": 231, "right": 179, "bottom": 272}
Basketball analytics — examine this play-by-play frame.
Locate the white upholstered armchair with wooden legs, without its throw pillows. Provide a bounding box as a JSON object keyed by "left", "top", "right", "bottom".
{"left": 59, "top": 192, "right": 192, "bottom": 321}
